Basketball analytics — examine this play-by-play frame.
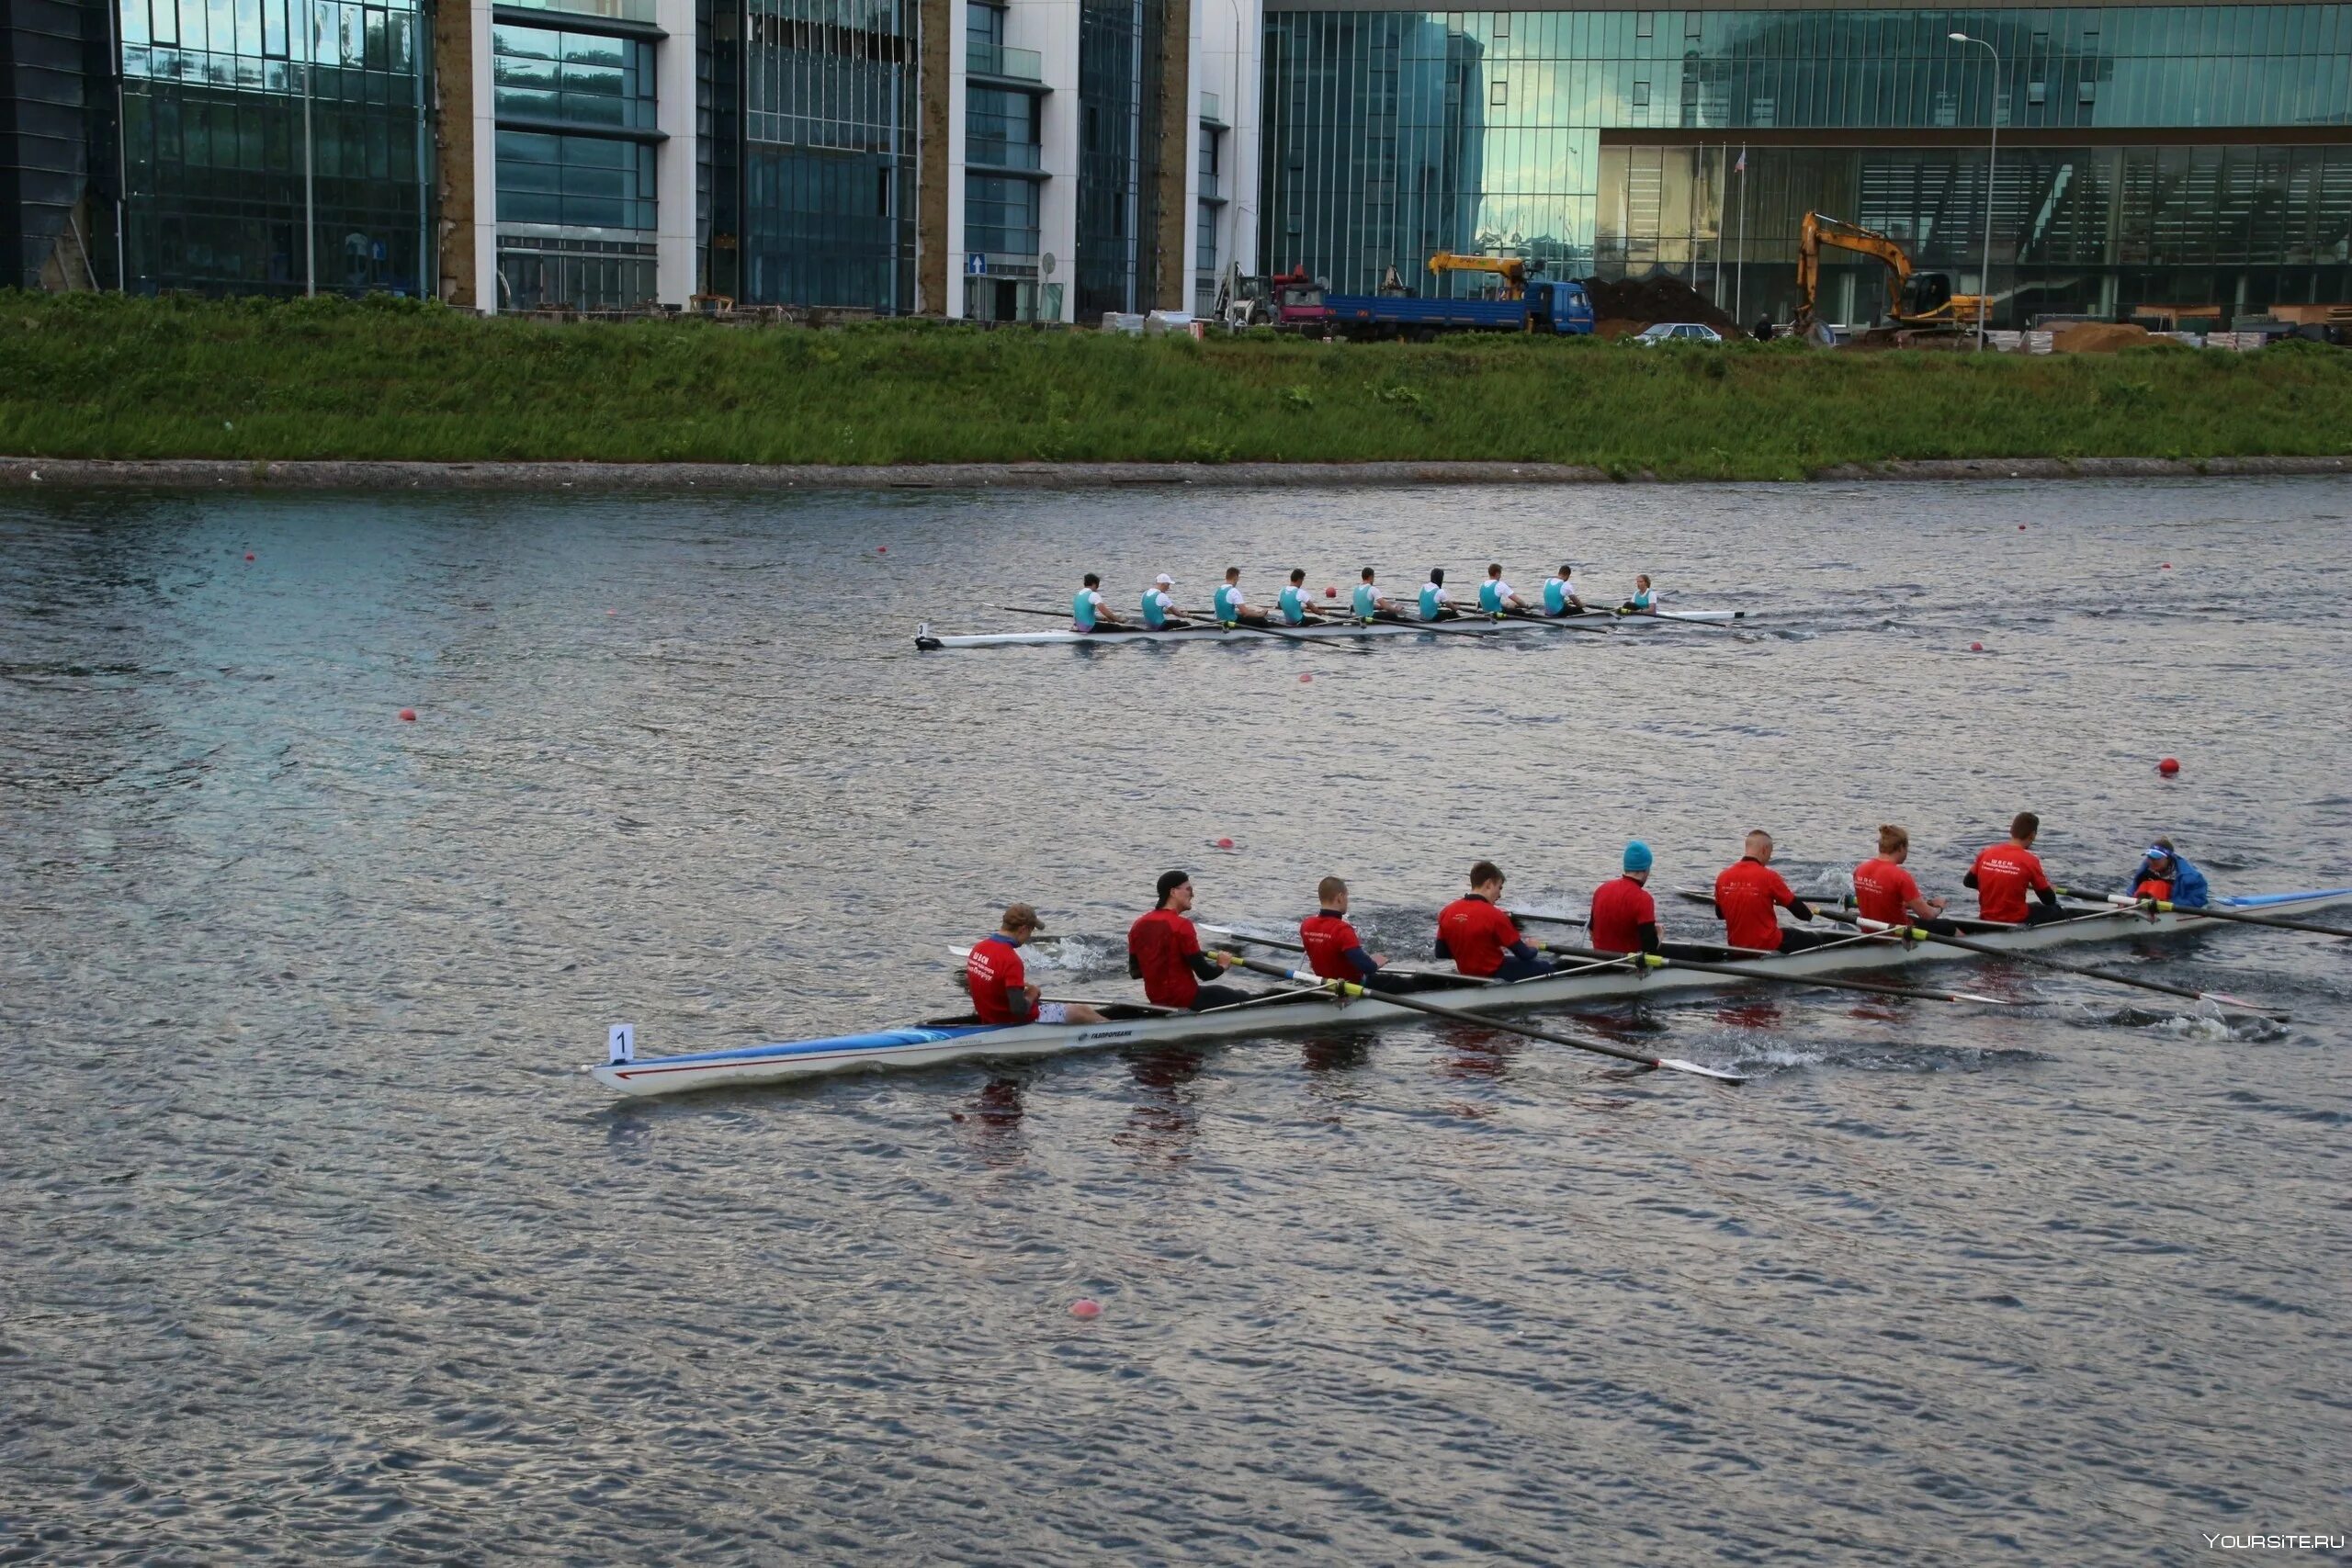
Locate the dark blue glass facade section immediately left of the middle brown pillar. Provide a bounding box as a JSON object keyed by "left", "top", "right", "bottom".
{"left": 741, "top": 0, "right": 917, "bottom": 315}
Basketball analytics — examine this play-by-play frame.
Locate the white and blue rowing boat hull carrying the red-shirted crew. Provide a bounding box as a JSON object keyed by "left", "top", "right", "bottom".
{"left": 588, "top": 888, "right": 2352, "bottom": 1096}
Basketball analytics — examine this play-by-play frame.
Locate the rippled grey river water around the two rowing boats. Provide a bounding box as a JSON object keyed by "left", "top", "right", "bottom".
{"left": 0, "top": 479, "right": 2352, "bottom": 1563}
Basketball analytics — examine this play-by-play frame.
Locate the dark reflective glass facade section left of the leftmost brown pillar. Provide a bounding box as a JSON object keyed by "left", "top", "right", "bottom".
{"left": 104, "top": 0, "right": 433, "bottom": 294}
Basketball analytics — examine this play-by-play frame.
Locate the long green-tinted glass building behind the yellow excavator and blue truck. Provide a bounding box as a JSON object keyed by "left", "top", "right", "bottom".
{"left": 1263, "top": 5, "right": 2352, "bottom": 320}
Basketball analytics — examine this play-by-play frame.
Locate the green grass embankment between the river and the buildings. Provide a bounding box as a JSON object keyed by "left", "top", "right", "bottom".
{"left": 14, "top": 294, "right": 2352, "bottom": 479}
